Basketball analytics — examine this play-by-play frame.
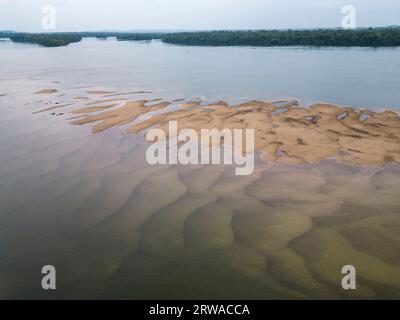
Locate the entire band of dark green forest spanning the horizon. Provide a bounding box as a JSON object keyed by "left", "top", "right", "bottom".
{"left": 0, "top": 27, "right": 400, "bottom": 47}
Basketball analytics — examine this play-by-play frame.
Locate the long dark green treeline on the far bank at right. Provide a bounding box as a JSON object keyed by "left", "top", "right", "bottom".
{"left": 162, "top": 28, "right": 400, "bottom": 47}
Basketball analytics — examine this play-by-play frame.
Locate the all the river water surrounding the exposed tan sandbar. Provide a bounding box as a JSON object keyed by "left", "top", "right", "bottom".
{"left": 0, "top": 39, "right": 400, "bottom": 299}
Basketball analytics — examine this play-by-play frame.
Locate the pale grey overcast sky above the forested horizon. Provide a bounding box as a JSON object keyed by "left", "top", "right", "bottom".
{"left": 0, "top": 0, "right": 400, "bottom": 32}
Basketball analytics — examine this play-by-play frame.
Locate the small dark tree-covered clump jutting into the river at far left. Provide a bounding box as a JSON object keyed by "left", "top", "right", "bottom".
{"left": 5, "top": 33, "right": 82, "bottom": 47}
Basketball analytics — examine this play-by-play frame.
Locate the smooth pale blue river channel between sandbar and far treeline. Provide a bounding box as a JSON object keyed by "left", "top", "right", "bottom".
{"left": 0, "top": 39, "right": 400, "bottom": 109}
